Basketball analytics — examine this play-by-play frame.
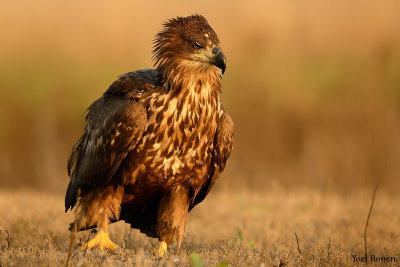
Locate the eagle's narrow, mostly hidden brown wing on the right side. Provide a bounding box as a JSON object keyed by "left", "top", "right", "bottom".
{"left": 189, "top": 107, "right": 234, "bottom": 210}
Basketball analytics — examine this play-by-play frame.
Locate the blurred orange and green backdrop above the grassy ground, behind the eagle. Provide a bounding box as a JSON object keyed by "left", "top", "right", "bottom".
{"left": 0, "top": 0, "right": 400, "bottom": 194}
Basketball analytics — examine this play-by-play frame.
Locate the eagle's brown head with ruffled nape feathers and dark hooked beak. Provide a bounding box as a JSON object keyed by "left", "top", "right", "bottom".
{"left": 153, "top": 15, "right": 226, "bottom": 86}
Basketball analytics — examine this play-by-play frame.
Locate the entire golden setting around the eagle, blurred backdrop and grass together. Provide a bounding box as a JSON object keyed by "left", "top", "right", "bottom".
{"left": 0, "top": 0, "right": 400, "bottom": 266}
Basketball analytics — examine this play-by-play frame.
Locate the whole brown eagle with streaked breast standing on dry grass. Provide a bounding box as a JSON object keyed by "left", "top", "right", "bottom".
{"left": 65, "top": 14, "right": 234, "bottom": 257}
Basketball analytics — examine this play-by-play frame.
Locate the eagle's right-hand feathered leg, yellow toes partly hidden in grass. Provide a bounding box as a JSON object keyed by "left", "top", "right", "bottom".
{"left": 156, "top": 185, "right": 189, "bottom": 257}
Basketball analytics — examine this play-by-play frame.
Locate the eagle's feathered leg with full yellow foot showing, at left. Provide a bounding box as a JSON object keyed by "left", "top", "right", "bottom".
{"left": 77, "top": 185, "right": 124, "bottom": 250}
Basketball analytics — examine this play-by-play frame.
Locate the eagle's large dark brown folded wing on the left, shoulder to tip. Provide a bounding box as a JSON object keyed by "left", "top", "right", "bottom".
{"left": 65, "top": 70, "right": 158, "bottom": 210}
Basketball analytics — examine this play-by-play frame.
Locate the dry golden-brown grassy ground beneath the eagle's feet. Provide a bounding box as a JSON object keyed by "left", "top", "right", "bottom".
{"left": 0, "top": 188, "right": 400, "bottom": 266}
